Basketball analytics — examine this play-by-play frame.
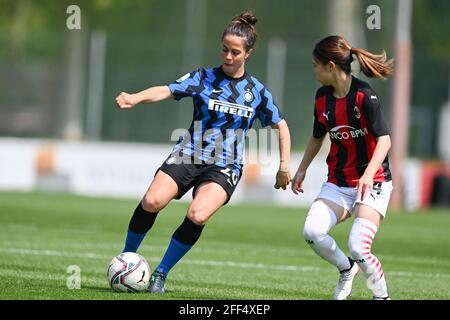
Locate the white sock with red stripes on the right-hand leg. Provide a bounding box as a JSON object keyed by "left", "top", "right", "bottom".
{"left": 348, "top": 218, "right": 388, "bottom": 298}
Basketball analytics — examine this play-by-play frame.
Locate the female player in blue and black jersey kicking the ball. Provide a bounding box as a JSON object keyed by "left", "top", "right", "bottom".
{"left": 116, "top": 12, "right": 291, "bottom": 293}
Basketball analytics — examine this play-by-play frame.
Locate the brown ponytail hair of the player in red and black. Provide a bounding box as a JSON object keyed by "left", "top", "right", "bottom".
{"left": 313, "top": 36, "right": 394, "bottom": 79}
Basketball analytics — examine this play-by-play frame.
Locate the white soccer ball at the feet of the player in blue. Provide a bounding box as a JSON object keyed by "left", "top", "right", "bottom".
{"left": 108, "top": 252, "right": 150, "bottom": 292}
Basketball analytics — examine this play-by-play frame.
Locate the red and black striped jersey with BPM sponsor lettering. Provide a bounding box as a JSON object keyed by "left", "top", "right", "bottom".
{"left": 313, "top": 77, "right": 392, "bottom": 187}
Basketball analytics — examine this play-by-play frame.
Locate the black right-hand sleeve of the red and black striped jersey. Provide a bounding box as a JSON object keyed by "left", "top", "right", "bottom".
{"left": 362, "top": 90, "right": 390, "bottom": 137}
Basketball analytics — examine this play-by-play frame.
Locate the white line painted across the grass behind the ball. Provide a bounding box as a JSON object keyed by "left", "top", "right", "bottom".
{"left": 0, "top": 247, "right": 450, "bottom": 278}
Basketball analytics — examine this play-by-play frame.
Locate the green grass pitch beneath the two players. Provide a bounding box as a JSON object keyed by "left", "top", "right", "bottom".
{"left": 0, "top": 192, "right": 450, "bottom": 300}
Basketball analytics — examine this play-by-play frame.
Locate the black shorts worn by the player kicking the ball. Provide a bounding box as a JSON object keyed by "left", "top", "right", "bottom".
{"left": 155, "top": 160, "right": 242, "bottom": 204}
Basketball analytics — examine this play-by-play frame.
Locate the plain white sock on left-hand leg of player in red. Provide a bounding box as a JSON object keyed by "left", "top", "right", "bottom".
{"left": 303, "top": 201, "right": 351, "bottom": 271}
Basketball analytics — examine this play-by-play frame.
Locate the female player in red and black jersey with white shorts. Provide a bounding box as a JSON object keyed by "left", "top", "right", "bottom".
{"left": 291, "top": 36, "right": 393, "bottom": 300}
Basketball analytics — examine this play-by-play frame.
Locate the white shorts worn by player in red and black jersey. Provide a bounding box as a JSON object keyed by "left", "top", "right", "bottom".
{"left": 316, "top": 181, "right": 393, "bottom": 217}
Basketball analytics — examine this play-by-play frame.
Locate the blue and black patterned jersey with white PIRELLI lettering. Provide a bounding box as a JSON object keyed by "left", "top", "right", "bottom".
{"left": 168, "top": 67, "right": 283, "bottom": 170}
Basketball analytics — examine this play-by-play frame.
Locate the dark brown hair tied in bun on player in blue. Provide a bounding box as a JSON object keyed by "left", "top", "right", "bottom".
{"left": 222, "top": 12, "right": 258, "bottom": 51}
